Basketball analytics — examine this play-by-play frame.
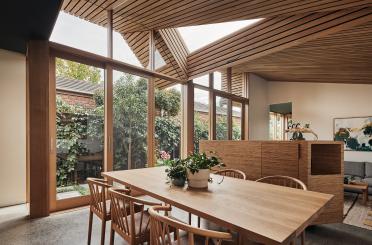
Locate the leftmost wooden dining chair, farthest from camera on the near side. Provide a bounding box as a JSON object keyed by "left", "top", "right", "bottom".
{"left": 87, "top": 178, "right": 111, "bottom": 245}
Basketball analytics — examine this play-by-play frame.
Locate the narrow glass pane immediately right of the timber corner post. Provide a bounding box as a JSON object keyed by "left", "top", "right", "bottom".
{"left": 194, "top": 88, "right": 209, "bottom": 152}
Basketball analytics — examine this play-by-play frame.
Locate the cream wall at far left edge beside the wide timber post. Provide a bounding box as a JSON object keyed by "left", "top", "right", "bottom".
{"left": 0, "top": 49, "right": 26, "bottom": 207}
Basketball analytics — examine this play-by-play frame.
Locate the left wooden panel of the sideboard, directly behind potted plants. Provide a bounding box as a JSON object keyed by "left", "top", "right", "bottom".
{"left": 200, "top": 141, "right": 262, "bottom": 180}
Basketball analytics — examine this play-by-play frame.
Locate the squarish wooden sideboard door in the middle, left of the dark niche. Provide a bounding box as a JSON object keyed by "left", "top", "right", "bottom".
{"left": 262, "top": 142, "right": 299, "bottom": 178}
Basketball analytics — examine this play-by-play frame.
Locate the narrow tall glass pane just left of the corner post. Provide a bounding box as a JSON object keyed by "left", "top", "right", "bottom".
{"left": 155, "top": 85, "right": 181, "bottom": 165}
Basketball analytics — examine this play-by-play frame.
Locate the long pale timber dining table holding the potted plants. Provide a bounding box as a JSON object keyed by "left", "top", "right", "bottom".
{"left": 102, "top": 167, "right": 333, "bottom": 244}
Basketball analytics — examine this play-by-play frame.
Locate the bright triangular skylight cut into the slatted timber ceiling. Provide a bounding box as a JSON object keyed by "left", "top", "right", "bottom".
{"left": 177, "top": 19, "right": 261, "bottom": 52}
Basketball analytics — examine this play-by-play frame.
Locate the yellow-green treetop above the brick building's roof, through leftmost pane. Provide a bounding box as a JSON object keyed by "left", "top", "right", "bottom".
{"left": 56, "top": 58, "right": 101, "bottom": 83}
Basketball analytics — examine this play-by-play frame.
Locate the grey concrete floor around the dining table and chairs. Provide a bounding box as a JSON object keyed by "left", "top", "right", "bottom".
{"left": 0, "top": 205, "right": 372, "bottom": 245}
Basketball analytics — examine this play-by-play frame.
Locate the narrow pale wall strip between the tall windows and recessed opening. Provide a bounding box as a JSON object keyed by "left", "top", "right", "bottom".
{"left": 248, "top": 74, "right": 270, "bottom": 140}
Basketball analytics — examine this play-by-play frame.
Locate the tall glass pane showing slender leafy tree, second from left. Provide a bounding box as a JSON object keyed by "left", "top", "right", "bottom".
{"left": 113, "top": 71, "right": 148, "bottom": 170}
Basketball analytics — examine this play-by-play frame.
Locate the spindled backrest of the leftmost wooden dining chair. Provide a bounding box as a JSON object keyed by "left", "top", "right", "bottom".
{"left": 87, "top": 178, "right": 111, "bottom": 218}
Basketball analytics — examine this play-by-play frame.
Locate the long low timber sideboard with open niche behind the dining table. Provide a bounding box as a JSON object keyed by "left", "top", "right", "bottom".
{"left": 200, "top": 140, "right": 344, "bottom": 224}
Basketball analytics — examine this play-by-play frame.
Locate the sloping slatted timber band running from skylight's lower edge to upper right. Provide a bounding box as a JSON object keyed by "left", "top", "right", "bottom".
{"left": 187, "top": 8, "right": 372, "bottom": 77}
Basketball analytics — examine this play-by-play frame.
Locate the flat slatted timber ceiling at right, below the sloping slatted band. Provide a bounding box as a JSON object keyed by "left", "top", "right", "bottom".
{"left": 234, "top": 22, "right": 372, "bottom": 84}
